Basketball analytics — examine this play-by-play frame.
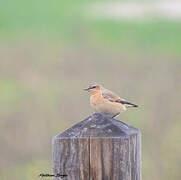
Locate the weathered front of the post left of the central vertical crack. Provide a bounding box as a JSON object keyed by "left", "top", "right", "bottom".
{"left": 53, "top": 137, "right": 89, "bottom": 180}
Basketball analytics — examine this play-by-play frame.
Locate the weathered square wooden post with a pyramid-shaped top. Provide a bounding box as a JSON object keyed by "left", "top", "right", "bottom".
{"left": 53, "top": 113, "right": 141, "bottom": 180}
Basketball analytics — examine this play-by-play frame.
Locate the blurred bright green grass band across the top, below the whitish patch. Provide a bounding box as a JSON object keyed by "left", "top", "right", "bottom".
{"left": 0, "top": 0, "right": 181, "bottom": 56}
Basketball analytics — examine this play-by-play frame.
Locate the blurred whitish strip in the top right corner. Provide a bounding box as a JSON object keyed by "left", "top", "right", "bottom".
{"left": 85, "top": 0, "right": 181, "bottom": 20}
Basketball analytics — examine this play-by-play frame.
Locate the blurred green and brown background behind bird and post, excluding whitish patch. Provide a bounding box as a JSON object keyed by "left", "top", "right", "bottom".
{"left": 0, "top": 0, "right": 181, "bottom": 180}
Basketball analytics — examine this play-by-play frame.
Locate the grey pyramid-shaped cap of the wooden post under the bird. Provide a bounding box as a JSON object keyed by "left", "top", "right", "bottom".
{"left": 55, "top": 113, "right": 139, "bottom": 139}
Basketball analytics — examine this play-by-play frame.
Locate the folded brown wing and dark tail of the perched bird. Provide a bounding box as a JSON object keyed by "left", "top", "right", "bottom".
{"left": 101, "top": 88, "right": 138, "bottom": 107}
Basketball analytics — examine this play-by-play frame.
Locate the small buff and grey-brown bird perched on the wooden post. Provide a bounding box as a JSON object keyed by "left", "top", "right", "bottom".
{"left": 84, "top": 83, "right": 138, "bottom": 118}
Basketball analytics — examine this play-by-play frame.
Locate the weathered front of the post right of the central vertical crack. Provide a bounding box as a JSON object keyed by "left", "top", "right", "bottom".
{"left": 90, "top": 135, "right": 141, "bottom": 180}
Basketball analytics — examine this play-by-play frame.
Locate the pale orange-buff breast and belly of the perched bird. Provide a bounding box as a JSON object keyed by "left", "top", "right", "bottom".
{"left": 90, "top": 94, "right": 126, "bottom": 116}
